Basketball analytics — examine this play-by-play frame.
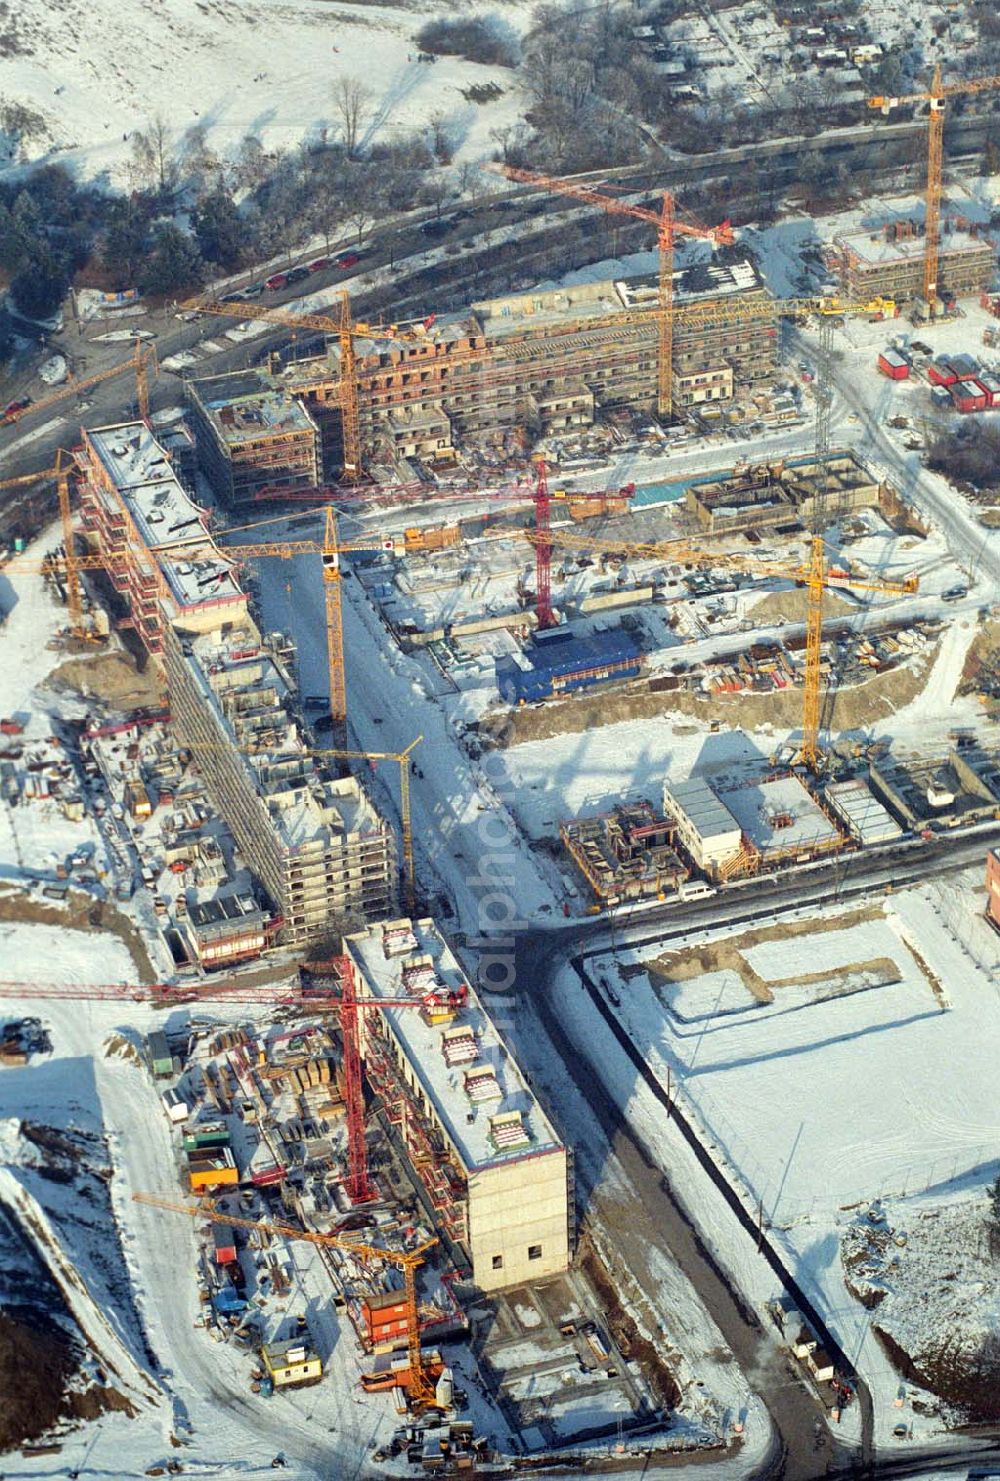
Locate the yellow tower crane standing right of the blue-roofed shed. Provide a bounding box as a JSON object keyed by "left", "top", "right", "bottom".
{"left": 529, "top": 529, "right": 920, "bottom": 772}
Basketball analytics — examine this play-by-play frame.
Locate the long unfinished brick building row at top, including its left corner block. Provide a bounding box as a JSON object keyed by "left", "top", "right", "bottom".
{"left": 190, "top": 249, "right": 776, "bottom": 485}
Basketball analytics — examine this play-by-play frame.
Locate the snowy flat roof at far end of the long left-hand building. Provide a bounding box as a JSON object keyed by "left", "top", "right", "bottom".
{"left": 86, "top": 422, "right": 207, "bottom": 549}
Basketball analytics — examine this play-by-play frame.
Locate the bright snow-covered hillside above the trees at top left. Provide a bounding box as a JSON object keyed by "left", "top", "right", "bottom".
{"left": 0, "top": 0, "right": 530, "bottom": 185}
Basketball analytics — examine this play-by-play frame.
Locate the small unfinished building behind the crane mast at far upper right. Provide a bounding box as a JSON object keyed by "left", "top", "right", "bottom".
{"left": 831, "top": 222, "right": 996, "bottom": 302}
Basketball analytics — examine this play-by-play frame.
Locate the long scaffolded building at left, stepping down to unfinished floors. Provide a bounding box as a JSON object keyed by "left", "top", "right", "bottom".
{"left": 80, "top": 422, "right": 397, "bottom": 942}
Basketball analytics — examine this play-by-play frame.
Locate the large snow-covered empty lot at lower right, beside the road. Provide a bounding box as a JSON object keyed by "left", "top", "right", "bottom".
{"left": 591, "top": 871, "right": 1000, "bottom": 1429}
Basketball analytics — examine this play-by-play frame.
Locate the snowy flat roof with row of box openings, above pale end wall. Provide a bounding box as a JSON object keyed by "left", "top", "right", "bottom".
{"left": 344, "top": 918, "right": 563, "bottom": 1171}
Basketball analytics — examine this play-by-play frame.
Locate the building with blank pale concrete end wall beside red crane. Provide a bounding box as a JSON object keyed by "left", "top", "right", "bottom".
{"left": 344, "top": 920, "right": 575, "bottom": 1291}
